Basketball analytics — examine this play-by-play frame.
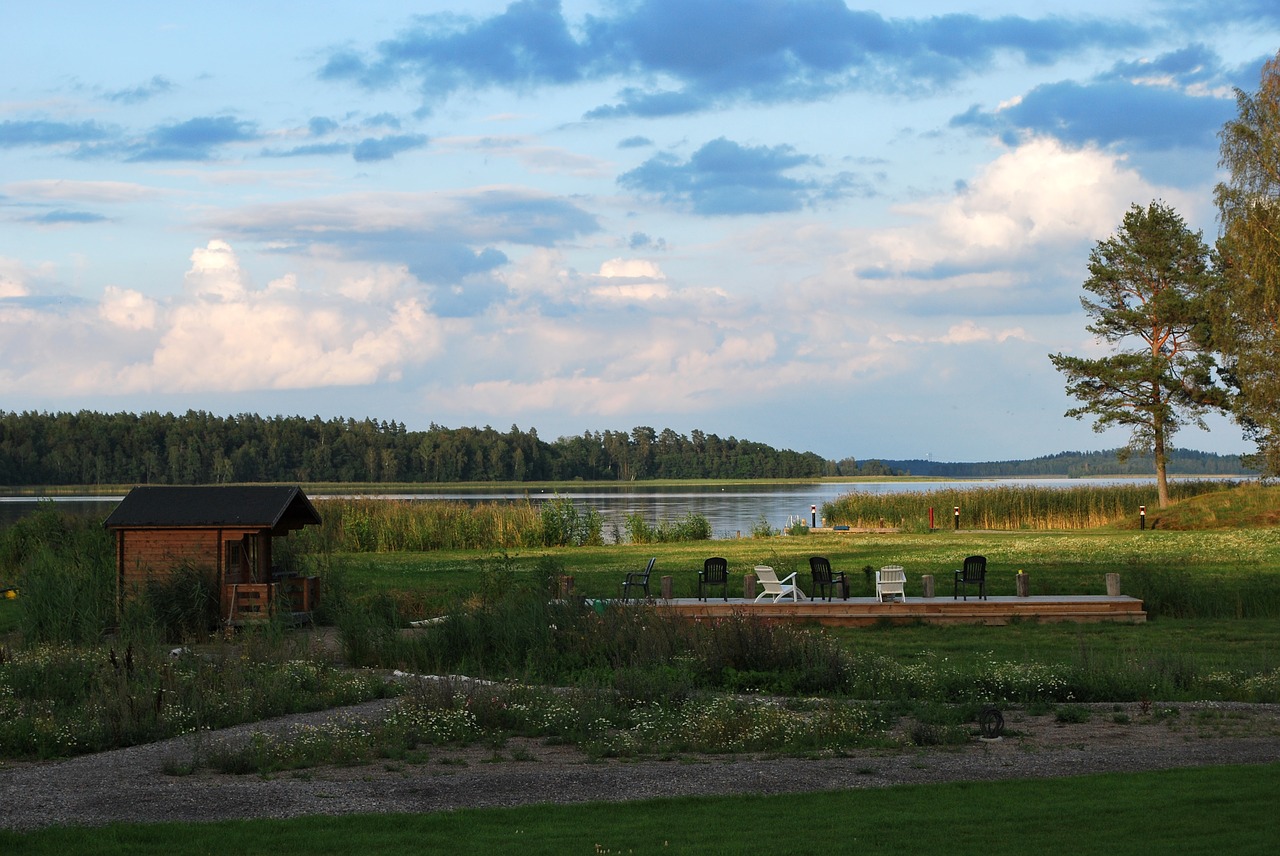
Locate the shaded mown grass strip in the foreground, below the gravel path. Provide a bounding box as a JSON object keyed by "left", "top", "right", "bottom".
{"left": 0, "top": 764, "right": 1280, "bottom": 856}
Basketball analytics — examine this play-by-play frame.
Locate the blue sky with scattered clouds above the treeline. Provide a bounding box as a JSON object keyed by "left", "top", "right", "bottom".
{"left": 0, "top": 0, "right": 1280, "bottom": 461}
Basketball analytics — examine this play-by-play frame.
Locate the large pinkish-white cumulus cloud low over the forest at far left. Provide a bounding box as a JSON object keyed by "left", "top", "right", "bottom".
{"left": 0, "top": 239, "right": 443, "bottom": 394}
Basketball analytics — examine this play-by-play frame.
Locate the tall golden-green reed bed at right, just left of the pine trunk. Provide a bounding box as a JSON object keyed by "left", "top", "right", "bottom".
{"left": 822, "top": 480, "right": 1234, "bottom": 532}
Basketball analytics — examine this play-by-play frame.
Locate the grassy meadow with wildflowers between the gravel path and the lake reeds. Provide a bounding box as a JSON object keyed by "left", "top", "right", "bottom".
{"left": 0, "top": 487, "right": 1280, "bottom": 852}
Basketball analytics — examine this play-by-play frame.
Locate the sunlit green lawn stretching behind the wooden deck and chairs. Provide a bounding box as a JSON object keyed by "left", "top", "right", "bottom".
{"left": 328, "top": 528, "right": 1280, "bottom": 617}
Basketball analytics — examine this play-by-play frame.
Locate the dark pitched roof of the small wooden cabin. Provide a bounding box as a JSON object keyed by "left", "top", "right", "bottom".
{"left": 102, "top": 485, "right": 320, "bottom": 532}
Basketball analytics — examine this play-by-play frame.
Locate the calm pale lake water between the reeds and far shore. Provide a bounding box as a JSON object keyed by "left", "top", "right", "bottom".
{"left": 0, "top": 479, "right": 1198, "bottom": 539}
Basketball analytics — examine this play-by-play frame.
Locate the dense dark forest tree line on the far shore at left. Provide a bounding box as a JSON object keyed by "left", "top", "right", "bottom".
{"left": 0, "top": 411, "right": 839, "bottom": 485}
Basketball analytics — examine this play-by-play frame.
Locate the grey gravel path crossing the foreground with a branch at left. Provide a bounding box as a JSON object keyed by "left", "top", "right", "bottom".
{"left": 0, "top": 700, "right": 1280, "bottom": 829}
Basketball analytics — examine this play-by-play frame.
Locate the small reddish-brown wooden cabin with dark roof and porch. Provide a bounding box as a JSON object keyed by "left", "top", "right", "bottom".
{"left": 104, "top": 485, "right": 320, "bottom": 624}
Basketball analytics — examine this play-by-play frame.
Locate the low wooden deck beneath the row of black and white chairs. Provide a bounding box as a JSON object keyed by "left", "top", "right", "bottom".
{"left": 653, "top": 595, "right": 1147, "bottom": 627}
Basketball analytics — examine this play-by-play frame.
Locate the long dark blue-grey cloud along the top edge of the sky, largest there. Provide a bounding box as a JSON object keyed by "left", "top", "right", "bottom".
{"left": 320, "top": 0, "right": 1148, "bottom": 118}
